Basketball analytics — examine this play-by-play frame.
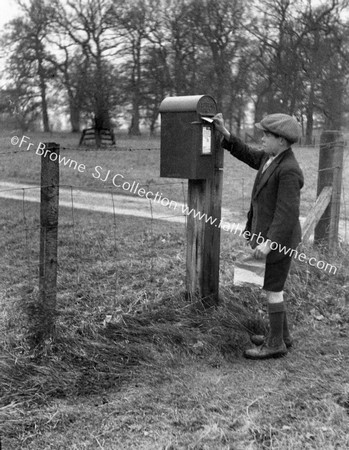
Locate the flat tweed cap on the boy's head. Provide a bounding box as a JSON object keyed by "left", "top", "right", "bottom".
{"left": 256, "top": 113, "right": 300, "bottom": 143}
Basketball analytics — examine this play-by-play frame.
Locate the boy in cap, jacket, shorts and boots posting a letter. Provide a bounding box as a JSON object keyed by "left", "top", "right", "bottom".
{"left": 214, "top": 114, "right": 304, "bottom": 359}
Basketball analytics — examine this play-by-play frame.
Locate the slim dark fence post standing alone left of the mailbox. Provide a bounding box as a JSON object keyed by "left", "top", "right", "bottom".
{"left": 30, "top": 142, "right": 59, "bottom": 345}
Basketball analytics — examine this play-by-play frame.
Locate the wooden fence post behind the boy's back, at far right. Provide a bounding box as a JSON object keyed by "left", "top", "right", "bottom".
{"left": 314, "top": 131, "right": 344, "bottom": 249}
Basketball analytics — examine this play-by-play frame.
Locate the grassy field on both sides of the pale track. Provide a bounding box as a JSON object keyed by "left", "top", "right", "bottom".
{"left": 0, "top": 128, "right": 349, "bottom": 450}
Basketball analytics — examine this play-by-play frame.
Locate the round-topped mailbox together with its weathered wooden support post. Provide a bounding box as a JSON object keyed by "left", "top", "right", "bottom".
{"left": 160, "top": 95, "right": 223, "bottom": 307}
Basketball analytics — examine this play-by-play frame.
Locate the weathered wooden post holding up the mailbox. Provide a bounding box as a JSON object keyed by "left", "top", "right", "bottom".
{"left": 186, "top": 130, "right": 223, "bottom": 307}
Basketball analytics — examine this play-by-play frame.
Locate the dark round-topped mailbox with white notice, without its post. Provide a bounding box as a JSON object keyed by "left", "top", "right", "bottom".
{"left": 160, "top": 95, "right": 217, "bottom": 180}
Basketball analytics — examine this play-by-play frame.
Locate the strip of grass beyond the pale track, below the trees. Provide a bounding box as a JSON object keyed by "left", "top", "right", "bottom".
{"left": 0, "top": 127, "right": 349, "bottom": 218}
